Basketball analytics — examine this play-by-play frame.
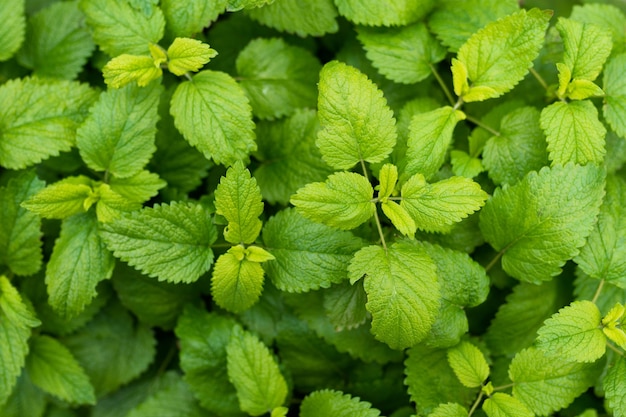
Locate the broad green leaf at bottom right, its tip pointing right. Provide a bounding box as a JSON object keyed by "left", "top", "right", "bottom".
{"left": 509, "top": 348, "right": 602, "bottom": 416}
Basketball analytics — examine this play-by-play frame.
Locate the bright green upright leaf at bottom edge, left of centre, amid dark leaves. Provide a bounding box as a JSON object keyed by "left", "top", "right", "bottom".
{"left": 226, "top": 326, "right": 288, "bottom": 416}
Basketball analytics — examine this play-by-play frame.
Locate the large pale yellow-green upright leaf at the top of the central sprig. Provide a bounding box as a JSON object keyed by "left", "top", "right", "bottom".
{"left": 317, "top": 61, "right": 397, "bottom": 169}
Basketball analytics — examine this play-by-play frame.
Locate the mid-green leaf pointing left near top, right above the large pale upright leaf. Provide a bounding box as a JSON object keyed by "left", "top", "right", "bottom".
{"left": 357, "top": 22, "right": 446, "bottom": 84}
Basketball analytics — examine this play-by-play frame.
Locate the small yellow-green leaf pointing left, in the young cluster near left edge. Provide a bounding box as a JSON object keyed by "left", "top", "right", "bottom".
{"left": 22, "top": 175, "right": 97, "bottom": 219}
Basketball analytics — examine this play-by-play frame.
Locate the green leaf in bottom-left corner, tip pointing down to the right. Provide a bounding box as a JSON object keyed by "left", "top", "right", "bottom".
{"left": 26, "top": 336, "right": 96, "bottom": 404}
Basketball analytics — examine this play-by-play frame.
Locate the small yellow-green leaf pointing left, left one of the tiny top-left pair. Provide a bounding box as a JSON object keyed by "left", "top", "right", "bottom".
{"left": 102, "top": 54, "right": 163, "bottom": 88}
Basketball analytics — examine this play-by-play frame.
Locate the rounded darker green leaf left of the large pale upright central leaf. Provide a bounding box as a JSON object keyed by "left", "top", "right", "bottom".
{"left": 236, "top": 38, "right": 321, "bottom": 119}
